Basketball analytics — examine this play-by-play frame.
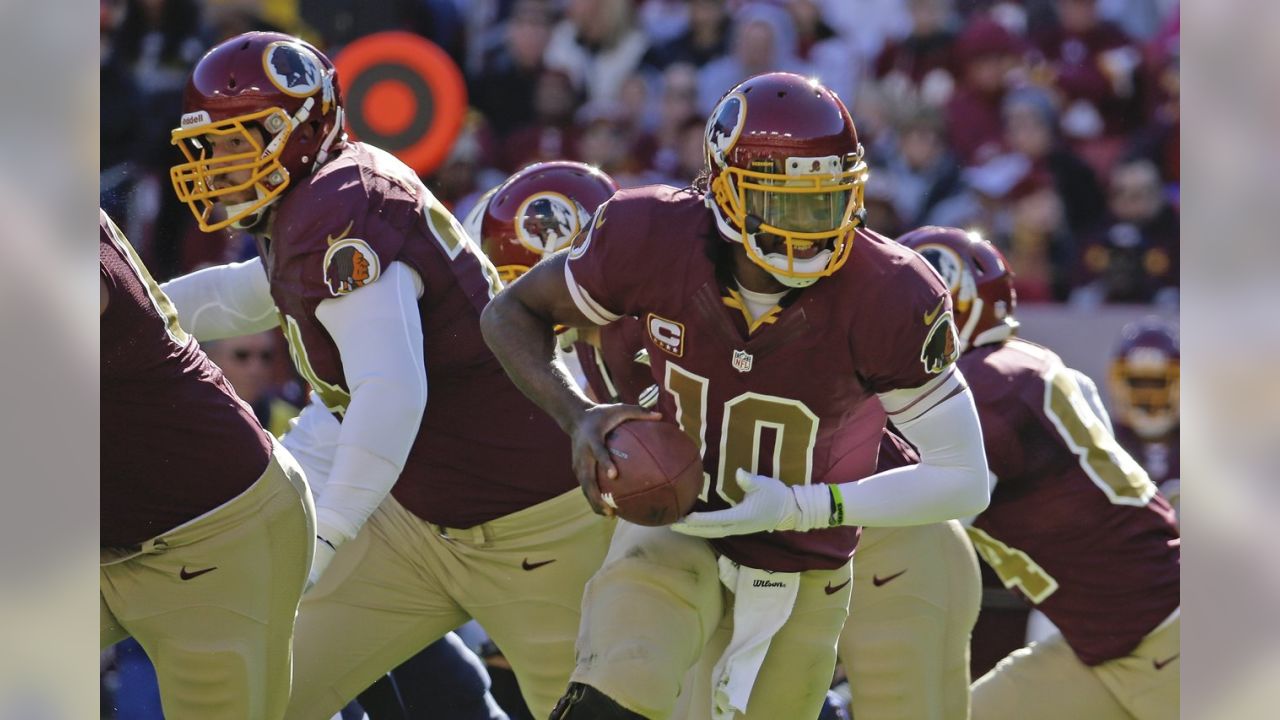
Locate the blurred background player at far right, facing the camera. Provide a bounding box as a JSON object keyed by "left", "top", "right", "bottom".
{"left": 1110, "top": 318, "right": 1181, "bottom": 514}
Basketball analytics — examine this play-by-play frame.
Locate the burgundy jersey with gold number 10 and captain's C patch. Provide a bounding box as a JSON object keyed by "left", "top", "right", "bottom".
{"left": 567, "top": 186, "right": 952, "bottom": 571}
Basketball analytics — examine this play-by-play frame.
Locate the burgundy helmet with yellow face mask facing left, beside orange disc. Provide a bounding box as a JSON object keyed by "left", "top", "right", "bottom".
{"left": 169, "top": 32, "right": 342, "bottom": 232}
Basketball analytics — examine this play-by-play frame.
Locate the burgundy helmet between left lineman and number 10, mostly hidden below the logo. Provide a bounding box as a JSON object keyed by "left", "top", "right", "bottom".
{"left": 463, "top": 160, "right": 618, "bottom": 283}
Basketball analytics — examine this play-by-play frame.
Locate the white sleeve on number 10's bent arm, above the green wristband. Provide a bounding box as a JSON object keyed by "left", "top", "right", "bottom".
{"left": 840, "top": 370, "right": 991, "bottom": 527}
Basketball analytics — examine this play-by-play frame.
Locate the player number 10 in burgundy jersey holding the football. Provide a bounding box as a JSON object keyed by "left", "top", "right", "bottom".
{"left": 481, "top": 73, "right": 988, "bottom": 719}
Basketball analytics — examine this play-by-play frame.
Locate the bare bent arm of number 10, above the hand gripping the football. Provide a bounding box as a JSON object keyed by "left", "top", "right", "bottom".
{"left": 480, "top": 255, "right": 595, "bottom": 434}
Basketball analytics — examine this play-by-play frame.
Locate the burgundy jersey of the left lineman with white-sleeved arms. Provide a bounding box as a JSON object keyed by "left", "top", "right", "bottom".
{"left": 259, "top": 142, "right": 577, "bottom": 528}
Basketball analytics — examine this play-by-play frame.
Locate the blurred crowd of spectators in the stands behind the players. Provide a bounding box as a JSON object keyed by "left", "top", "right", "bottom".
{"left": 100, "top": 0, "right": 1179, "bottom": 304}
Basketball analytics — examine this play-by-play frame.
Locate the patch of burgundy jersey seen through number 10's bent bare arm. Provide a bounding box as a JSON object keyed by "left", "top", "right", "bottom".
{"left": 573, "top": 318, "right": 654, "bottom": 405}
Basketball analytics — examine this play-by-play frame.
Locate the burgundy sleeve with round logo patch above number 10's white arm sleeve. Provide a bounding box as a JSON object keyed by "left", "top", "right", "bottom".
{"left": 854, "top": 256, "right": 960, "bottom": 393}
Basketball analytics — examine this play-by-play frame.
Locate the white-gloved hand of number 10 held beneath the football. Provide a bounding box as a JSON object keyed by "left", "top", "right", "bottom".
{"left": 671, "top": 469, "right": 831, "bottom": 538}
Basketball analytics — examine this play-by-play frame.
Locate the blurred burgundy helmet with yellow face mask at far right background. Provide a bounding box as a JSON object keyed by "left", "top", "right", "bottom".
{"left": 1110, "top": 318, "right": 1181, "bottom": 439}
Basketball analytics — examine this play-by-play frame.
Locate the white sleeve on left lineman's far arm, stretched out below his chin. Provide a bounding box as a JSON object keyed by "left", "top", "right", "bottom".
{"left": 160, "top": 258, "right": 280, "bottom": 341}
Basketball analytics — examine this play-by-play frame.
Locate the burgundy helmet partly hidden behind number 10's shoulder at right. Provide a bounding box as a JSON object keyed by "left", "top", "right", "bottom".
{"left": 897, "top": 225, "right": 1018, "bottom": 352}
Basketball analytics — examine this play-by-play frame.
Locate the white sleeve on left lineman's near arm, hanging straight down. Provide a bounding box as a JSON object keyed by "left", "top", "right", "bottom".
{"left": 316, "top": 263, "right": 426, "bottom": 544}
